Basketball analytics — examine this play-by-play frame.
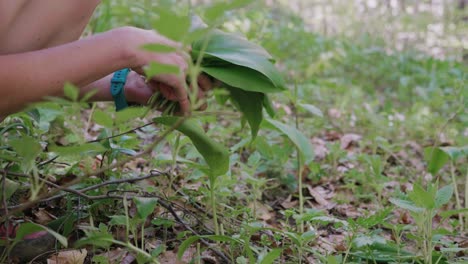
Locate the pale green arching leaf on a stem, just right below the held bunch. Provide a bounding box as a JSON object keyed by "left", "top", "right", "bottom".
{"left": 266, "top": 119, "right": 314, "bottom": 164}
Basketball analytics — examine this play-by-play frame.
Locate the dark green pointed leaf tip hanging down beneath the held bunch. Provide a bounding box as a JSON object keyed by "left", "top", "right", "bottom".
{"left": 229, "top": 89, "right": 263, "bottom": 140}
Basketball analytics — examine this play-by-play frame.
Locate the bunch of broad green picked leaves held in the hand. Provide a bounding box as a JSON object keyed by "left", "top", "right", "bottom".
{"left": 192, "top": 30, "right": 285, "bottom": 138}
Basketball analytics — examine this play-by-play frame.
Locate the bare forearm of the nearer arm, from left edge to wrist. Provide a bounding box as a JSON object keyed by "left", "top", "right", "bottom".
{"left": 0, "top": 26, "right": 136, "bottom": 115}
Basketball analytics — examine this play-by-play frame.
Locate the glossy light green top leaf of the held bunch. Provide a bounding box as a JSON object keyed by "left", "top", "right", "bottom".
{"left": 192, "top": 30, "right": 285, "bottom": 88}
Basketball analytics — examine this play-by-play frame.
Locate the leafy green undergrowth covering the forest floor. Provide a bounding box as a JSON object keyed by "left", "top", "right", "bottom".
{"left": 0, "top": 1, "right": 468, "bottom": 264}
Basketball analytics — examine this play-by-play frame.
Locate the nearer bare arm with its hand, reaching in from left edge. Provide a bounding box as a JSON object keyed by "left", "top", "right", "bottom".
{"left": 0, "top": 28, "right": 187, "bottom": 116}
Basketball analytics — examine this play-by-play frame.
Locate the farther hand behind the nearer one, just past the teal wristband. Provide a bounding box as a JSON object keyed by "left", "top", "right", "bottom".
{"left": 124, "top": 71, "right": 219, "bottom": 111}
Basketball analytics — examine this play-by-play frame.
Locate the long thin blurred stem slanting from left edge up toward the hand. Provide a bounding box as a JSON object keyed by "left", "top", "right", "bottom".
{"left": 0, "top": 116, "right": 188, "bottom": 222}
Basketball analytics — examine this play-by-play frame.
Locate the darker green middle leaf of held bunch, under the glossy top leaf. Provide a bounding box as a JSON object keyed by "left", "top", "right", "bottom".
{"left": 202, "top": 65, "right": 283, "bottom": 93}
